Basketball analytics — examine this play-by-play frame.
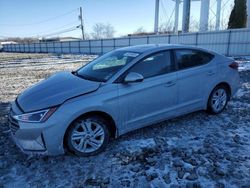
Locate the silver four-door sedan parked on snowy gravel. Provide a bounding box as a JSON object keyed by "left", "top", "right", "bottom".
{"left": 9, "top": 45, "right": 239, "bottom": 156}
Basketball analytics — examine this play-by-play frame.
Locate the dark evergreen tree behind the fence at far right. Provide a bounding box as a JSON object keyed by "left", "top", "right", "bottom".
{"left": 228, "top": 0, "right": 247, "bottom": 29}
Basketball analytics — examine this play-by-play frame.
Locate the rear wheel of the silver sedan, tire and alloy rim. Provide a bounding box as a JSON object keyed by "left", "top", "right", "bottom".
{"left": 207, "top": 85, "right": 230, "bottom": 114}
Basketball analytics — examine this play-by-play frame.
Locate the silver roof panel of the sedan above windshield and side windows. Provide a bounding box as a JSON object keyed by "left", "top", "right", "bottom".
{"left": 118, "top": 44, "right": 214, "bottom": 53}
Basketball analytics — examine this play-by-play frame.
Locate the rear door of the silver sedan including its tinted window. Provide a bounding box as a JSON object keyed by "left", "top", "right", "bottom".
{"left": 175, "top": 49, "right": 217, "bottom": 113}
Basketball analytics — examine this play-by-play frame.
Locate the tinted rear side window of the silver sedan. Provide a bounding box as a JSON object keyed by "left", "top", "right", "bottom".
{"left": 175, "top": 50, "right": 214, "bottom": 69}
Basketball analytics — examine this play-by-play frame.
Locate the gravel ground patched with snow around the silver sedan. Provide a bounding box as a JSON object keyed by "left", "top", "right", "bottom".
{"left": 0, "top": 53, "right": 250, "bottom": 187}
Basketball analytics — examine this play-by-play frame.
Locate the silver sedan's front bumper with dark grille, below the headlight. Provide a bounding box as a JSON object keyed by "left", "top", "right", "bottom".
{"left": 9, "top": 103, "right": 67, "bottom": 155}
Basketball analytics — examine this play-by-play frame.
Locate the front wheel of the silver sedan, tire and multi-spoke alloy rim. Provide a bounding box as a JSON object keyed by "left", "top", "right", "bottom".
{"left": 66, "top": 116, "right": 110, "bottom": 157}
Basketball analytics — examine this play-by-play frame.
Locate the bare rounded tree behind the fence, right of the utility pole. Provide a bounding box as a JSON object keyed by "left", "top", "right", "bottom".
{"left": 91, "top": 23, "right": 115, "bottom": 39}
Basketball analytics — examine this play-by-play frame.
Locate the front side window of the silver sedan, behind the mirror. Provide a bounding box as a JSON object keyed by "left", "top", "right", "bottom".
{"left": 129, "top": 51, "right": 174, "bottom": 78}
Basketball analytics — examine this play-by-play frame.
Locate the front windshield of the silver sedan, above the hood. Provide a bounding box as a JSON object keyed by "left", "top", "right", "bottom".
{"left": 77, "top": 50, "right": 139, "bottom": 82}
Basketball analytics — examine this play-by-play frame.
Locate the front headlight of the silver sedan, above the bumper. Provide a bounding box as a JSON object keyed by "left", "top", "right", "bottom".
{"left": 13, "top": 107, "right": 56, "bottom": 123}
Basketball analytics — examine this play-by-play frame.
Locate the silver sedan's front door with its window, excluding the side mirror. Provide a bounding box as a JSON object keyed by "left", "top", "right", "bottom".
{"left": 118, "top": 51, "right": 178, "bottom": 133}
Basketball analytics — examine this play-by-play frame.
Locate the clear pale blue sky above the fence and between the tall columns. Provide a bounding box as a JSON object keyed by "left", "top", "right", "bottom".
{"left": 0, "top": 0, "right": 233, "bottom": 37}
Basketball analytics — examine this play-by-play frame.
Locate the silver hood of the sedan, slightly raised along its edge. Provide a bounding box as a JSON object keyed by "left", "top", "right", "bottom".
{"left": 17, "top": 72, "right": 100, "bottom": 112}
